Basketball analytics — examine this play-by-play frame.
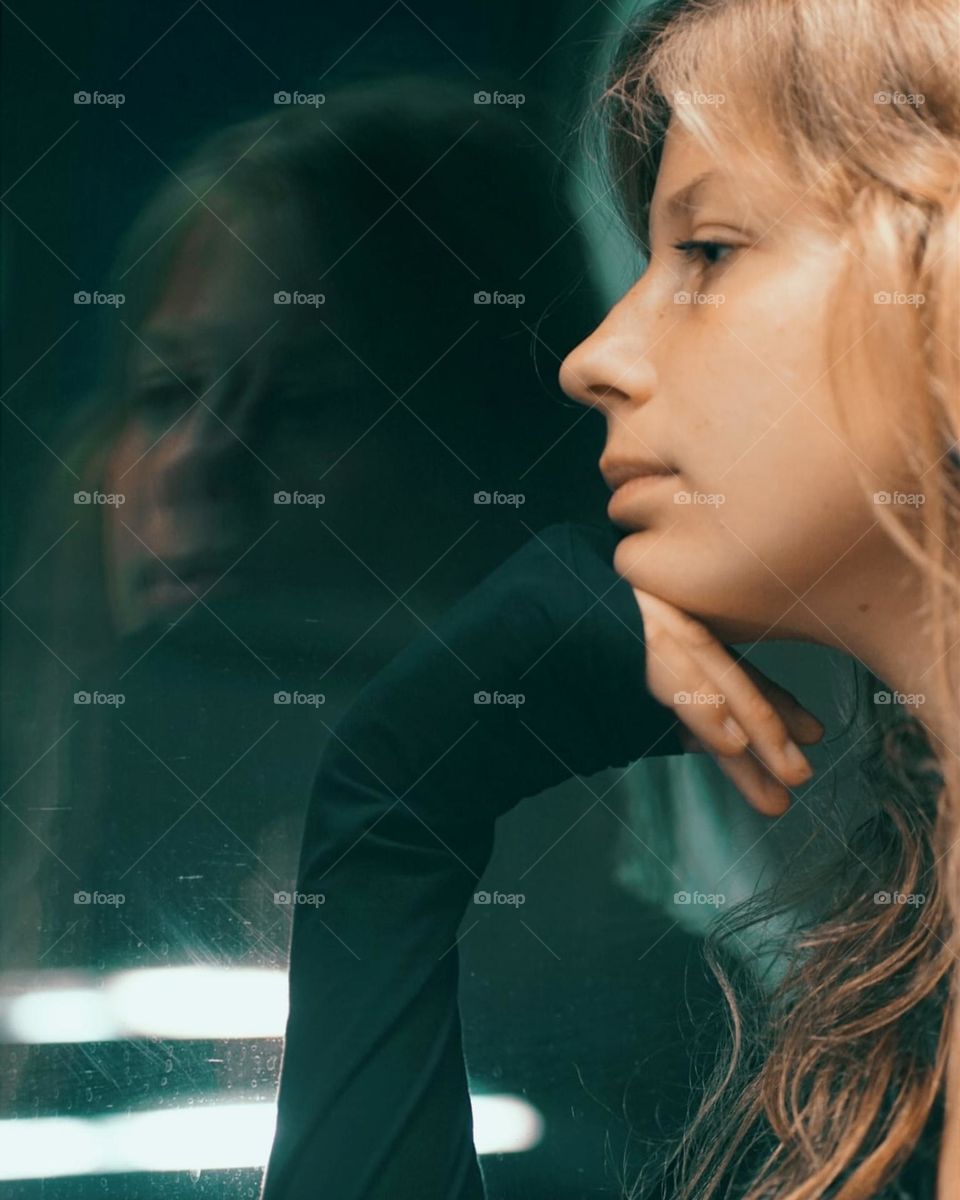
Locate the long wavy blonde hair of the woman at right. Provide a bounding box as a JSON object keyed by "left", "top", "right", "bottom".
{"left": 599, "top": 0, "right": 960, "bottom": 1200}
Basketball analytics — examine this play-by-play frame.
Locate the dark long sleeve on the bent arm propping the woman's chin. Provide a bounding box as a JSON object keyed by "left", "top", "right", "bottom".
{"left": 263, "top": 523, "right": 682, "bottom": 1200}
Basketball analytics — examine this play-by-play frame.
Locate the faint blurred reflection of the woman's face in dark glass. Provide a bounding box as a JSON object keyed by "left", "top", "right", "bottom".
{"left": 107, "top": 222, "right": 270, "bottom": 628}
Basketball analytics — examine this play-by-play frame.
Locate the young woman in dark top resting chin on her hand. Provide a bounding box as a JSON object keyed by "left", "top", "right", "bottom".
{"left": 265, "top": 0, "right": 960, "bottom": 1200}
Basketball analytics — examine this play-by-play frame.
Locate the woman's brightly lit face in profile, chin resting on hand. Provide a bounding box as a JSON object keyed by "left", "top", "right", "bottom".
{"left": 560, "top": 120, "right": 904, "bottom": 644}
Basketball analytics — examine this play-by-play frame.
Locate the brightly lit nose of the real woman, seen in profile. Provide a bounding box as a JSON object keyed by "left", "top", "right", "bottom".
{"left": 559, "top": 293, "right": 656, "bottom": 412}
